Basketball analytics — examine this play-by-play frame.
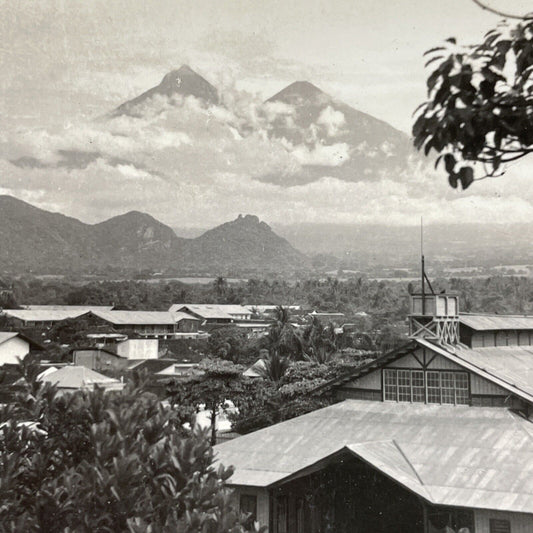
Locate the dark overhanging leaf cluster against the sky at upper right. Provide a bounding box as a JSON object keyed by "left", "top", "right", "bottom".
{"left": 413, "top": 18, "right": 533, "bottom": 189}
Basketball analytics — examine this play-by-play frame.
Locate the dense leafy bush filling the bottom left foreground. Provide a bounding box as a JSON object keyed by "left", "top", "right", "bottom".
{"left": 0, "top": 364, "right": 262, "bottom": 533}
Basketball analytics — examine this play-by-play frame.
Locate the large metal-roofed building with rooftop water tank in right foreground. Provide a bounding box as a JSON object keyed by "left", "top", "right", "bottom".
{"left": 216, "top": 294, "right": 533, "bottom": 533}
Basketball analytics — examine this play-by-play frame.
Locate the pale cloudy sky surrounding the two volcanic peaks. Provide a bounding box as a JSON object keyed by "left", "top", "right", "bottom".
{"left": 0, "top": 0, "right": 533, "bottom": 227}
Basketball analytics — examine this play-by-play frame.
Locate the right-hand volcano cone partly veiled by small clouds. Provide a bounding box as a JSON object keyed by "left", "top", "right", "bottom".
{"left": 265, "top": 81, "right": 417, "bottom": 185}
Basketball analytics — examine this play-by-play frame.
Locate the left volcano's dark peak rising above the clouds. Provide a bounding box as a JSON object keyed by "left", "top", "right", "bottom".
{"left": 112, "top": 65, "right": 219, "bottom": 116}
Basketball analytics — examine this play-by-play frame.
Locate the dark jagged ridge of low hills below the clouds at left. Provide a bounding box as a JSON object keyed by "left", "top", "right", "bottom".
{"left": 0, "top": 196, "right": 309, "bottom": 275}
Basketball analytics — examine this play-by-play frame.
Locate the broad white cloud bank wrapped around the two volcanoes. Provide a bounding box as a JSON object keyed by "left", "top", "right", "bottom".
{"left": 0, "top": 77, "right": 533, "bottom": 231}
